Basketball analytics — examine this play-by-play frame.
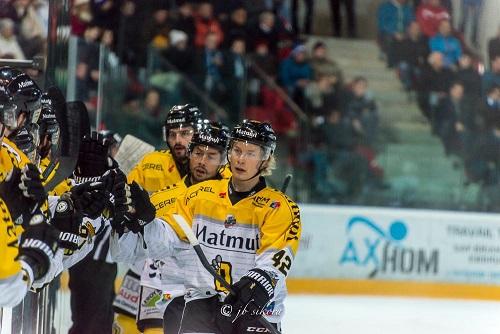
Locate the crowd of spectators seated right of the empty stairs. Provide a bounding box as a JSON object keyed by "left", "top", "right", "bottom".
{"left": 378, "top": 0, "right": 500, "bottom": 209}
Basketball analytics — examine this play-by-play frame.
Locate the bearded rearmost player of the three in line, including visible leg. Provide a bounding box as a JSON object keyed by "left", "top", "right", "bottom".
{"left": 114, "top": 104, "right": 202, "bottom": 334}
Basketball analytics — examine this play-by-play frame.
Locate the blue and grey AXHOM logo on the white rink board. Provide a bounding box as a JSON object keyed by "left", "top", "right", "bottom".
{"left": 339, "top": 216, "right": 439, "bottom": 278}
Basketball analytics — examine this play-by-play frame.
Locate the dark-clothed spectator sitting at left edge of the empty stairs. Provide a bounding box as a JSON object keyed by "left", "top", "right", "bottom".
{"left": 344, "top": 77, "right": 379, "bottom": 146}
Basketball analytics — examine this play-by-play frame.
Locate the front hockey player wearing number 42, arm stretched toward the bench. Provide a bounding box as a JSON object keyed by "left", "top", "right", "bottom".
{"left": 112, "top": 120, "right": 301, "bottom": 333}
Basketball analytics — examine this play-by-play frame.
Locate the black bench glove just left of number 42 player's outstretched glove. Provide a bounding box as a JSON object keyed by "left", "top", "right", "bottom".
{"left": 70, "top": 181, "right": 110, "bottom": 219}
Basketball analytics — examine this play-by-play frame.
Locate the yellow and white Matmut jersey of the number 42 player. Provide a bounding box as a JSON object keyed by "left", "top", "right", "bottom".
{"left": 158, "top": 179, "right": 301, "bottom": 322}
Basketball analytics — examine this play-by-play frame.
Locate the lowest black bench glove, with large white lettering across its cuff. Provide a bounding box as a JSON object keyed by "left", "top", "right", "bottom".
{"left": 17, "top": 214, "right": 59, "bottom": 280}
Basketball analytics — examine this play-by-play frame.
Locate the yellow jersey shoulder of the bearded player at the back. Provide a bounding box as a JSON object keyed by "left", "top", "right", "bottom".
{"left": 127, "top": 150, "right": 181, "bottom": 193}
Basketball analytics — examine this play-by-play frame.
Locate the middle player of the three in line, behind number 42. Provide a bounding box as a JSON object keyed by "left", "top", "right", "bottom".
{"left": 130, "top": 123, "right": 229, "bottom": 334}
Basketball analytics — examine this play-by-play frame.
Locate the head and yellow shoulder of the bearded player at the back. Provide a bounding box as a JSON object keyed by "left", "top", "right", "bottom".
{"left": 127, "top": 104, "right": 201, "bottom": 192}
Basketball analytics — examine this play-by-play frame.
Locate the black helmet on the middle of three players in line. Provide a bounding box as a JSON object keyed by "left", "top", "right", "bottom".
{"left": 189, "top": 122, "right": 229, "bottom": 155}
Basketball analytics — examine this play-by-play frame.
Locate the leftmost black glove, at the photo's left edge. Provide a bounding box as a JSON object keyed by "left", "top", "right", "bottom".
{"left": 0, "top": 164, "right": 47, "bottom": 225}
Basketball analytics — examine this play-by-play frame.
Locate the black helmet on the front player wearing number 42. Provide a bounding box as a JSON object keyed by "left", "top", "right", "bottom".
{"left": 229, "top": 119, "right": 276, "bottom": 159}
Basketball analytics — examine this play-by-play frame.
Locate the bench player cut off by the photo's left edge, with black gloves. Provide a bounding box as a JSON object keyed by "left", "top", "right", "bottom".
{"left": 0, "top": 86, "right": 58, "bottom": 306}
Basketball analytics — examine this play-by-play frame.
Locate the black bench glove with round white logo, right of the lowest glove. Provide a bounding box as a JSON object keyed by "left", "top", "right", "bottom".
{"left": 51, "top": 193, "right": 83, "bottom": 251}
